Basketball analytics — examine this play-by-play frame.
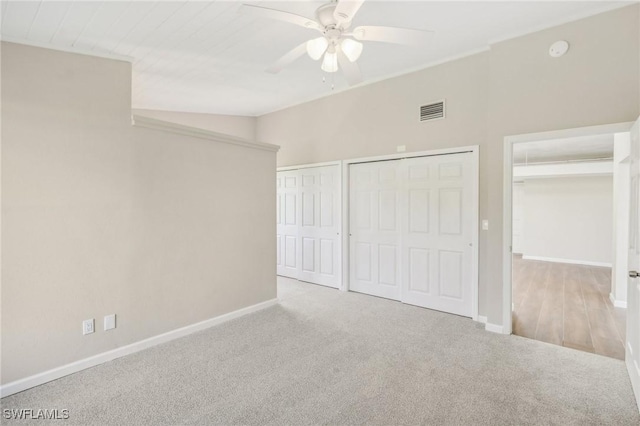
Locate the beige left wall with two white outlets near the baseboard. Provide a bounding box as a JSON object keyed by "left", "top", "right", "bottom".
{"left": 1, "top": 43, "right": 276, "bottom": 384}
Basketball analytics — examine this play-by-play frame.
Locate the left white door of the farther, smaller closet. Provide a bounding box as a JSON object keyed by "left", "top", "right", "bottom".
{"left": 276, "top": 170, "right": 300, "bottom": 278}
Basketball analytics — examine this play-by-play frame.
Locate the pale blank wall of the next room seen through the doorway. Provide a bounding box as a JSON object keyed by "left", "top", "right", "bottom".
{"left": 522, "top": 176, "right": 613, "bottom": 265}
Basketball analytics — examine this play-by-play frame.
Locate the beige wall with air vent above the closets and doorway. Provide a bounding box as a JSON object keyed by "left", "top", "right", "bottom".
{"left": 256, "top": 5, "right": 640, "bottom": 324}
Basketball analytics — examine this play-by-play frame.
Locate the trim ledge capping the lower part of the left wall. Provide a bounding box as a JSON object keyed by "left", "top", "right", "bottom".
{"left": 131, "top": 114, "right": 280, "bottom": 152}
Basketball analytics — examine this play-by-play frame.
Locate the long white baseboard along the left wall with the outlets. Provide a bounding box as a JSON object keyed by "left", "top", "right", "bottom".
{"left": 0, "top": 299, "right": 278, "bottom": 398}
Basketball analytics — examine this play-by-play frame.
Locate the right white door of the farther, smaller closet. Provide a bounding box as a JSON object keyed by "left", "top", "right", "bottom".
{"left": 298, "top": 165, "right": 342, "bottom": 288}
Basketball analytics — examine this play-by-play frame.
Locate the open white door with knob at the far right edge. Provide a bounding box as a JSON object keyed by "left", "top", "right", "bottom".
{"left": 625, "top": 119, "right": 640, "bottom": 407}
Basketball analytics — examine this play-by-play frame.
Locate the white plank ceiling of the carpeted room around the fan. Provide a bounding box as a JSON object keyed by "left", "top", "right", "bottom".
{"left": 1, "top": 0, "right": 630, "bottom": 116}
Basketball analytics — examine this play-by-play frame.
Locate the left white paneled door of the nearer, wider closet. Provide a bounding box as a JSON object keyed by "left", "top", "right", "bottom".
{"left": 349, "top": 160, "right": 401, "bottom": 300}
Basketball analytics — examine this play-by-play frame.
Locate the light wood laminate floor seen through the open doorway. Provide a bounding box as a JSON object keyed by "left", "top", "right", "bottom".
{"left": 512, "top": 255, "right": 626, "bottom": 359}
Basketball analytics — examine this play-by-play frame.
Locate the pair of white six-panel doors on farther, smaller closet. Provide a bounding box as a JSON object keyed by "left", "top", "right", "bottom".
{"left": 277, "top": 165, "right": 342, "bottom": 288}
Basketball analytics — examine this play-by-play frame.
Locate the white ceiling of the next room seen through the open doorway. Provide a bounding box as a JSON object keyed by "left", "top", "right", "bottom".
{"left": 513, "top": 134, "right": 613, "bottom": 164}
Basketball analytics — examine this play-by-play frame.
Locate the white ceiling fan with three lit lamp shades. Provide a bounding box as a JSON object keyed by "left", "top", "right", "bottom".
{"left": 240, "top": 0, "right": 433, "bottom": 86}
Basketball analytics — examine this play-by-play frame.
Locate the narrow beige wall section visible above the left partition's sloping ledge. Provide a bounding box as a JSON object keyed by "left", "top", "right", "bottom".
{"left": 131, "top": 108, "right": 256, "bottom": 140}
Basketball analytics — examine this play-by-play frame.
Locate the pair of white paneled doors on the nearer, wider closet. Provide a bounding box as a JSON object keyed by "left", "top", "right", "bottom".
{"left": 349, "top": 153, "right": 474, "bottom": 316}
